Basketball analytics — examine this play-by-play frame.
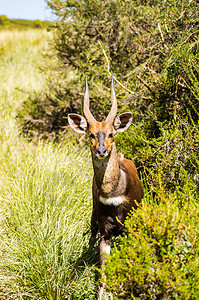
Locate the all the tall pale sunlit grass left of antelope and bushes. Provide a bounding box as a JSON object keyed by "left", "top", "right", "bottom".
{"left": 0, "top": 30, "right": 97, "bottom": 299}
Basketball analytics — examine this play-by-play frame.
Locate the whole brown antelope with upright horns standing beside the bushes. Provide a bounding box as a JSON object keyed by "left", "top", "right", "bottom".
{"left": 68, "top": 76, "right": 143, "bottom": 300}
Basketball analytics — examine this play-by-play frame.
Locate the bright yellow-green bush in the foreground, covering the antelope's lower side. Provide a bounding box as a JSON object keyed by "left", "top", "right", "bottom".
{"left": 105, "top": 187, "right": 199, "bottom": 300}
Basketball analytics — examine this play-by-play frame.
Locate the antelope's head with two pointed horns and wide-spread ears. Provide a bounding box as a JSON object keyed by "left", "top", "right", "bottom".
{"left": 68, "top": 76, "right": 132, "bottom": 159}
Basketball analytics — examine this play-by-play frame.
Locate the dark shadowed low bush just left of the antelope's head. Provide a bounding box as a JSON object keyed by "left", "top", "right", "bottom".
{"left": 17, "top": 70, "right": 80, "bottom": 140}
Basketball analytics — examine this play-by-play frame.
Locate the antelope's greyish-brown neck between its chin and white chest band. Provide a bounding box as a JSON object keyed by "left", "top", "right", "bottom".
{"left": 92, "top": 143, "right": 120, "bottom": 198}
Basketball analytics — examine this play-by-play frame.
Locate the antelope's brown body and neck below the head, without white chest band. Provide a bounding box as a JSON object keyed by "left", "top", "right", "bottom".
{"left": 91, "top": 143, "right": 143, "bottom": 265}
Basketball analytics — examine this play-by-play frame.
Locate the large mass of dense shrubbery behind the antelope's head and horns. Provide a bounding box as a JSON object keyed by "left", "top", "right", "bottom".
{"left": 18, "top": 0, "right": 199, "bottom": 187}
